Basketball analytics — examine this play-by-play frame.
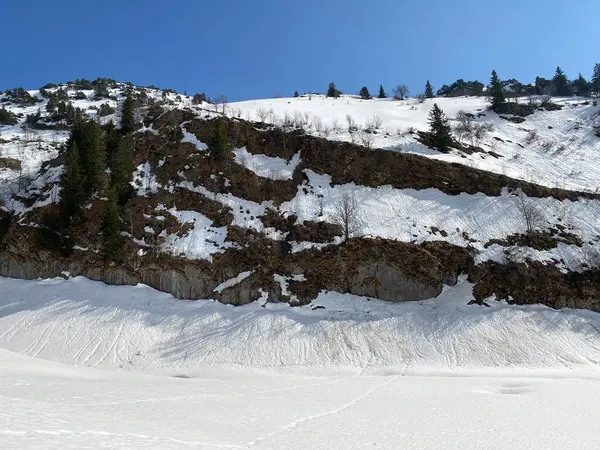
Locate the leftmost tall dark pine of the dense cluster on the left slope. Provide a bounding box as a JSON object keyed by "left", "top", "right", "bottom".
{"left": 60, "top": 142, "right": 85, "bottom": 221}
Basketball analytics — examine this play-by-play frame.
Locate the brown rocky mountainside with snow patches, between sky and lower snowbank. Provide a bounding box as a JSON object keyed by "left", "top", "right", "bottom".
{"left": 0, "top": 83, "right": 600, "bottom": 309}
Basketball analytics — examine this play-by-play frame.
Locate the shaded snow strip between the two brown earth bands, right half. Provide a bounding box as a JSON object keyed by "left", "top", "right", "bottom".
{"left": 279, "top": 169, "right": 600, "bottom": 270}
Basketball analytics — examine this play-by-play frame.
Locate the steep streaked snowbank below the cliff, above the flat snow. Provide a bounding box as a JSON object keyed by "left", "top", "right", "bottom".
{"left": 0, "top": 278, "right": 600, "bottom": 375}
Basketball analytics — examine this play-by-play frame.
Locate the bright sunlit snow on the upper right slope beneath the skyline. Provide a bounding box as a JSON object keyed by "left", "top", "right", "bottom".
{"left": 230, "top": 95, "right": 600, "bottom": 192}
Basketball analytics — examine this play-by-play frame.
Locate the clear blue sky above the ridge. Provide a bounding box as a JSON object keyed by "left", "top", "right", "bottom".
{"left": 0, "top": 0, "right": 600, "bottom": 100}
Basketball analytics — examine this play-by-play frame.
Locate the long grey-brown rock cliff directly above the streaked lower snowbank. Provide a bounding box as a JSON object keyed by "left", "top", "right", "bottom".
{"left": 0, "top": 225, "right": 470, "bottom": 305}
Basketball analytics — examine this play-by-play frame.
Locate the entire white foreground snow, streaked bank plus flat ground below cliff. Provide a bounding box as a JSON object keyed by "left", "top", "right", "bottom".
{"left": 0, "top": 278, "right": 600, "bottom": 450}
